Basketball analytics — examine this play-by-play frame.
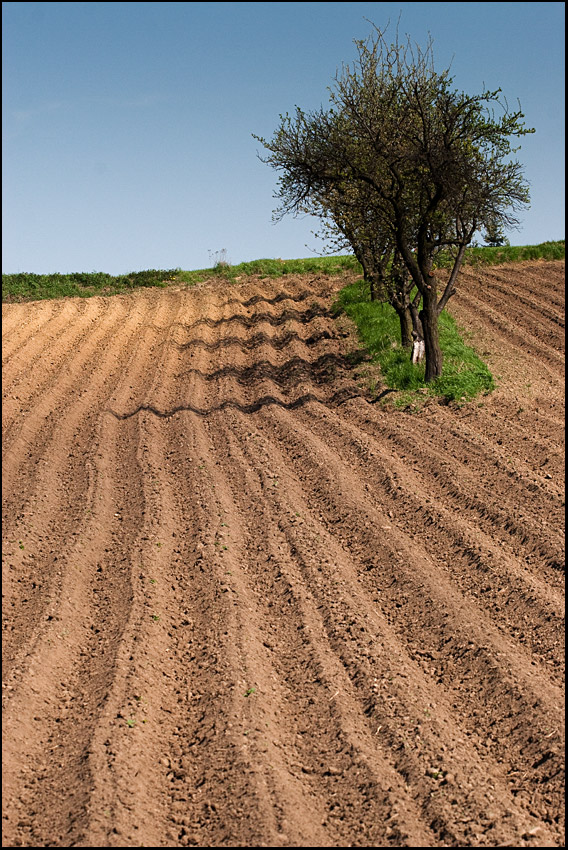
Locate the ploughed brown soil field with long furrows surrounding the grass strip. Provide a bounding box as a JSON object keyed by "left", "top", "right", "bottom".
{"left": 2, "top": 261, "right": 564, "bottom": 847}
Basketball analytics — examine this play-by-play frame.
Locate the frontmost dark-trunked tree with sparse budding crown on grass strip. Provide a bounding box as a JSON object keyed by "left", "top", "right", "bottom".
{"left": 255, "top": 27, "right": 534, "bottom": 381}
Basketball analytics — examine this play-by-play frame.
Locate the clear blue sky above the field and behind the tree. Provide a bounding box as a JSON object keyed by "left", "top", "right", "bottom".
{"left": 2, "top": 2, "right": 564, "bottom": 274}
